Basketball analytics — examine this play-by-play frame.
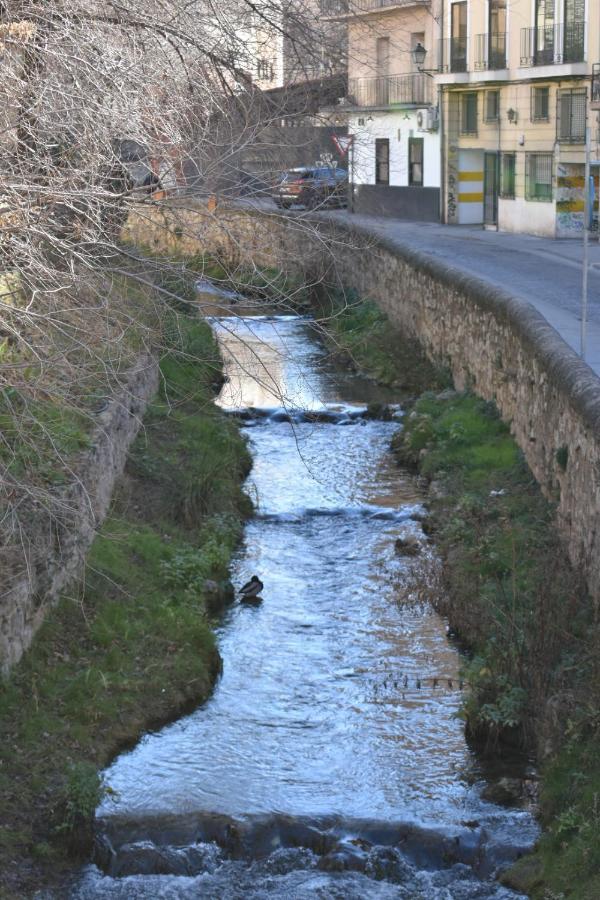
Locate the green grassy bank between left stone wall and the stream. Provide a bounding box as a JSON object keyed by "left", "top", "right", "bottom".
{"left": 0, "top": 311, "right": 250, "bottom": 898}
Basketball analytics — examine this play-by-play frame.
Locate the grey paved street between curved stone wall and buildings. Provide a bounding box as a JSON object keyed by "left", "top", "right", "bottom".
{"left": 318, "top": 210, "right": 600, "bottom": 376}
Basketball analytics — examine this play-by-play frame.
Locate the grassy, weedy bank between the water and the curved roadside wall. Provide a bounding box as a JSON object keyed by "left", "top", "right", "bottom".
{"left": 395, "top": 391, "right": 600, "bottom": 900}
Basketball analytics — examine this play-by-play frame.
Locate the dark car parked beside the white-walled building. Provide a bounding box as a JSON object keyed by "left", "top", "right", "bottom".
{"left": 273, "top": 166, "right": 348, "bottom": 209}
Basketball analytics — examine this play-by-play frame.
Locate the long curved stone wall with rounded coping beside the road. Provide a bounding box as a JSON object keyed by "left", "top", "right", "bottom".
{"left": 128, "top": 203, "right": 600, "bottom": 604}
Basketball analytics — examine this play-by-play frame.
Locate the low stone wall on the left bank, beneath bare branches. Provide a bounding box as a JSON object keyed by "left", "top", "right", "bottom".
{"left": 0, "top": 354, "right": 158, "bottom": 674}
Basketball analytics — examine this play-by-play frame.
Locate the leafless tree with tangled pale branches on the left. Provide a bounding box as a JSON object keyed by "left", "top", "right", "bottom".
{"left": 0, "top": 0, "right": 350, "bottom": 660}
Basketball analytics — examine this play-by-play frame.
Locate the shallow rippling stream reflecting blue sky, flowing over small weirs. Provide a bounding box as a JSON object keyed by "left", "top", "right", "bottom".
{"left": 71, "top": 316, "right": 536, "bottom": 900}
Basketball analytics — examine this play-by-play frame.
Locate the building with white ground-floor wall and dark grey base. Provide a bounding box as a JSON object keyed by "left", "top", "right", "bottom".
{"left": 321, "top": 0, "right": 440, "bottom": 221}
